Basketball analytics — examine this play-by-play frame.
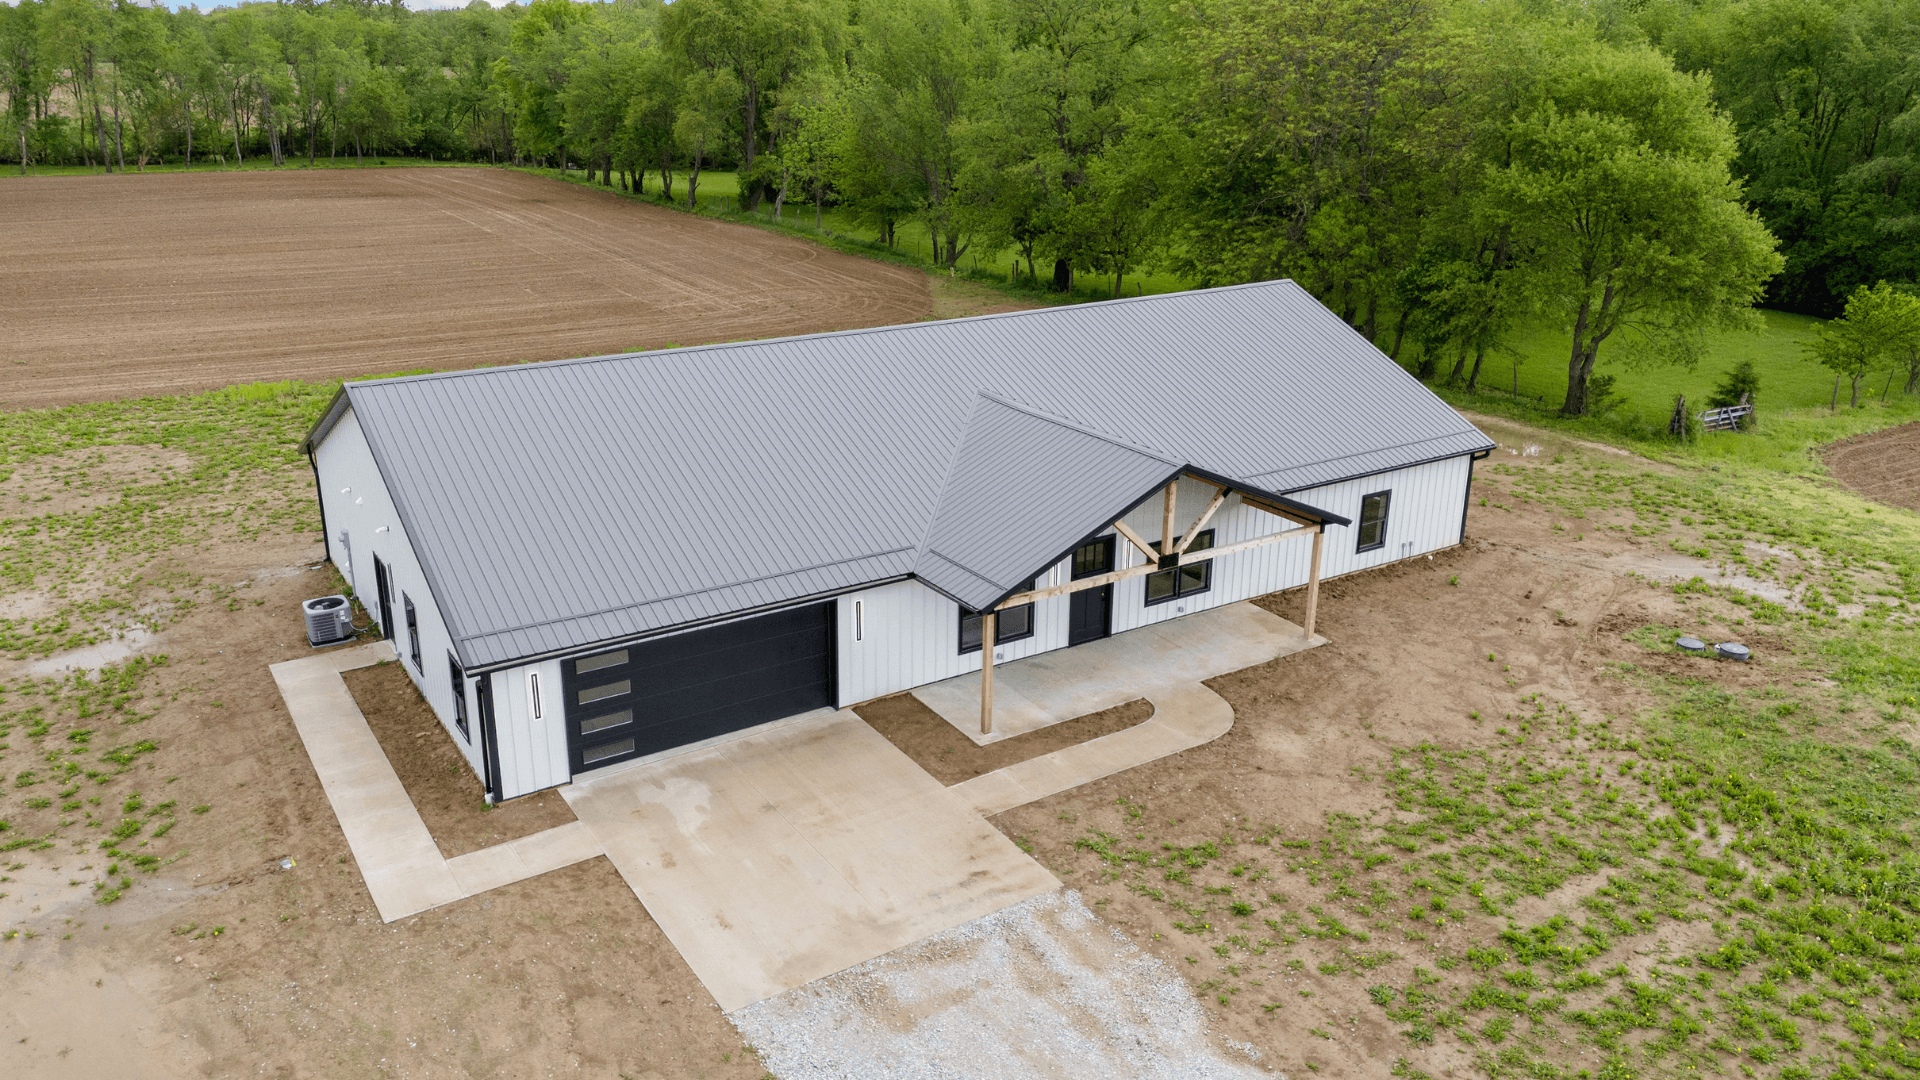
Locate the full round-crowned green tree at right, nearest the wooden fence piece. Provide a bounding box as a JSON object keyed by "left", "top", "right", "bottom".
{"left": 1490, "top": 38, "right": 1782, "bottom": 415}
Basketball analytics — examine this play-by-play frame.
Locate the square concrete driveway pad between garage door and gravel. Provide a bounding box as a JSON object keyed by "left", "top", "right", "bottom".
{"left": 561, "top": 711, "right": 1060, "bottom": 1013}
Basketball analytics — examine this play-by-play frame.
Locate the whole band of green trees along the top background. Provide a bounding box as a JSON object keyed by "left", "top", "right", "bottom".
{"left": 0, "top": 0, "right": 1920, "bottom": 415}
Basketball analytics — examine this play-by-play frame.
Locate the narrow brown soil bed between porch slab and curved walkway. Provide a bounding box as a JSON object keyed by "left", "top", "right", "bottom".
{"left": 854, "top": 694, "right": 1154, "bottom": 788}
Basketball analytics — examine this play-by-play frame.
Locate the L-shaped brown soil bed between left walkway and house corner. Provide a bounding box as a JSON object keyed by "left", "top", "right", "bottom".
{"left": 344, "top": 661, "right": 578, "bottom": 859}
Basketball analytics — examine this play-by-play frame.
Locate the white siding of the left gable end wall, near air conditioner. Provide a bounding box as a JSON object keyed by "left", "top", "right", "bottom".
{"left": 313, "top": 409, "right": 495, "bottom": 780}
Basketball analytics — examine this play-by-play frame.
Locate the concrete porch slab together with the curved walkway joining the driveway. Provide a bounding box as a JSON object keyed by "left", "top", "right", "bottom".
{"left": 914, "top": 603, "right": 1327, "bottom": 817}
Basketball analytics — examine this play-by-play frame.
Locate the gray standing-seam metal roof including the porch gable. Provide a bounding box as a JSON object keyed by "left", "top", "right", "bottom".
{"left": 309, "top": 281, "right": 1492, "bottom": 669}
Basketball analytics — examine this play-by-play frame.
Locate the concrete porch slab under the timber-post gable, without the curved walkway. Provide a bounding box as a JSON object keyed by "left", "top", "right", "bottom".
{"left": 912, "top": 601, "right": 1327, "bottom": 737}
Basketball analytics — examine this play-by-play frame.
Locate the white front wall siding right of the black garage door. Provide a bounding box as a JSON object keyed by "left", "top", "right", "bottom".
{"left": 835, "top": 455, "right": 1471, "bottom": 707}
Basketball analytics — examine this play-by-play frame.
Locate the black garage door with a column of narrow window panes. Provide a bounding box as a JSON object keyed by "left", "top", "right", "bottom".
{"left": 561, "top": 603, "right": 833, "bottom": 773}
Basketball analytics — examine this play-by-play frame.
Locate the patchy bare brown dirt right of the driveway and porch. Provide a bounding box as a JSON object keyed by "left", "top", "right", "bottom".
{"left": 995, "top": 409, "right": 1793, "bottom": 1076}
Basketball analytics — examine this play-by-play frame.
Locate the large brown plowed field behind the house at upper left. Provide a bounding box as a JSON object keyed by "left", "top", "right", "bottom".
{"left": 0, "top": 169, "right": 933, "bottom": 409}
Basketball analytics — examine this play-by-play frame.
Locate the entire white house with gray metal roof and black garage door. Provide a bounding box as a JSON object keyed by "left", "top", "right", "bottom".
{"left": 307, "top": 281, "right": 1492, "bottom": 799}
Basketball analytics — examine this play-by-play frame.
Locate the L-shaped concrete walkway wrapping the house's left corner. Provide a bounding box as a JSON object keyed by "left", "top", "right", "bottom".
{"left": 269, "top": 642, "right": 603, "bottom": 922}
